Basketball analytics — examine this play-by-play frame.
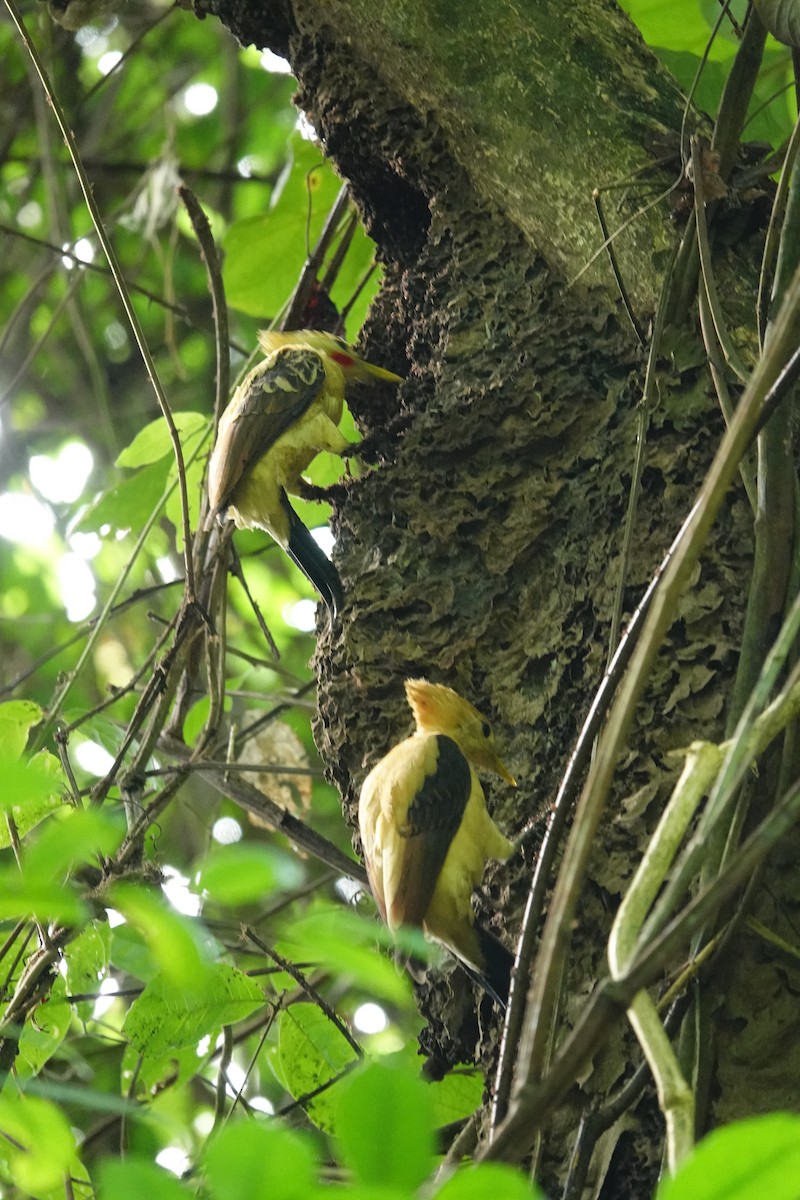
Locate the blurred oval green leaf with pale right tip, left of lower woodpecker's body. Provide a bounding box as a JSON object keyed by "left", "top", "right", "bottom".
{"left": 198, "top": 842, "right": 305, "bottom": 905}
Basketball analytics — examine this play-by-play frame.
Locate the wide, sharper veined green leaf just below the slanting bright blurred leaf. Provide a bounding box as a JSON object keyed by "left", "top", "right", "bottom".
{"left": 122, "top": 962, "right": 264, "bottom": 1057}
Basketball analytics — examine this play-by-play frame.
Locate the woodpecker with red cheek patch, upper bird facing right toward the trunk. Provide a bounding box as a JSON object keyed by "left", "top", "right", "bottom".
{"left": 209, "top": 329, "right": 401, "bottom": 614}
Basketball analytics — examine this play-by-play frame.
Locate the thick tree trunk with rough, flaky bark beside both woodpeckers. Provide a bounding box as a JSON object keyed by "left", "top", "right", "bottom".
{"left": 195, "top": 0, "right": 798, "bottom": 1198}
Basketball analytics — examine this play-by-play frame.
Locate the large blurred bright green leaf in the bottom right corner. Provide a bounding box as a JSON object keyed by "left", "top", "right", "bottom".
{"left": 657, "top": 1112, "right": 800, "bottom": 1200}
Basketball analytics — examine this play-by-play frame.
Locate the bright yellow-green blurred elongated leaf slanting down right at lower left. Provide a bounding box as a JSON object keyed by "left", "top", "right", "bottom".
{"left": 112, "top": 883, "right": 211, "bottom": 989}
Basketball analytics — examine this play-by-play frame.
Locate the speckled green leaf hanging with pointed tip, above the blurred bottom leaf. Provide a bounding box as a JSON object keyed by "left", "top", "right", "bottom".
{"left": 278, "top": 1004, "right": 356, "bottom": 1133}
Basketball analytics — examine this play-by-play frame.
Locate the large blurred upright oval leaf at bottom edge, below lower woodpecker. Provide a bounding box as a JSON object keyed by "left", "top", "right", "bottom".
{"left": 336, "top": 1062, "right": 434, "bottom": 1190}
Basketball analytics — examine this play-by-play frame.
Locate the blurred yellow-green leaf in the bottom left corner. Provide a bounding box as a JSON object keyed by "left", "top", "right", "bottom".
{"left": 0, "top": 1091, "right": 83, "bottom": 1196}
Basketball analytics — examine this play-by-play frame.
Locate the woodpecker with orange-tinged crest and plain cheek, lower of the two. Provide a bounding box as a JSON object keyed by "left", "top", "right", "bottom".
{"left": 359, "top": 679, "right": 516, "bottom": 1004}
